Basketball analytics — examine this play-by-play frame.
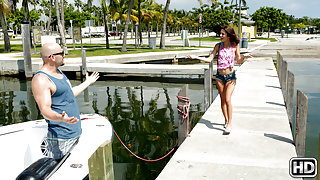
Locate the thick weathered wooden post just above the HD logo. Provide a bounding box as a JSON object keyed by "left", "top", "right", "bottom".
{"left": 294, "top": 90, "right": 308, "bottom": 157}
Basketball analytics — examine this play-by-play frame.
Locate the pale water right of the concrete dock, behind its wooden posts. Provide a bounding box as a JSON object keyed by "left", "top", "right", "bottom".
{"left": 288, "top": 59, "right": 320, "bottom": 165}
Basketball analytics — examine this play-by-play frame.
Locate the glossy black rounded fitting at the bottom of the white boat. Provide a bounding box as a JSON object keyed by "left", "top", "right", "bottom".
{"left": 16, "top": 157, "right": 58, "bottom": 180}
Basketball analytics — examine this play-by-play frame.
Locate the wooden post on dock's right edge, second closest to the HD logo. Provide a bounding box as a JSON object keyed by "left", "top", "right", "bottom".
{"left": 286, "top": 71, "right": 294, "bottom": 127}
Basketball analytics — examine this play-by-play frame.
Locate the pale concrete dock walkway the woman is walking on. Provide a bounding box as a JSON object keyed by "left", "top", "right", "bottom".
{"left": 157, "top": 58, "right": 297, "bottom": 180}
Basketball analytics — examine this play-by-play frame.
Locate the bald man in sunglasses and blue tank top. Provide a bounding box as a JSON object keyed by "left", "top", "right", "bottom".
{"left": 32, "top": 43, "right": 99, "bottom": 159}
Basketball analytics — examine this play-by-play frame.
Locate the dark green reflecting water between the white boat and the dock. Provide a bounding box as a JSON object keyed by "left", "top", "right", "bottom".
{"left": 0, "top": 77, "right": 209, "bottom": 180}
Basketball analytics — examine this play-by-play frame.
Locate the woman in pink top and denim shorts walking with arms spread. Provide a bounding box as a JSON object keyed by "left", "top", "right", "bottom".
{"left": 187, "top": 26, "right": 252, "bottom": 134}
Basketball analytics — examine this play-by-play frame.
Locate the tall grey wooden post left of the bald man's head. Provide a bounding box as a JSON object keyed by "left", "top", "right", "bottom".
{"left": 21, "top": 19, "right": 33, "bottom": 79}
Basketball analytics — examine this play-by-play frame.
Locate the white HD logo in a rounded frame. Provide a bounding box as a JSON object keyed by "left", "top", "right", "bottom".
{"left": 289, "top": 157, "right": 317, "bottom": 178}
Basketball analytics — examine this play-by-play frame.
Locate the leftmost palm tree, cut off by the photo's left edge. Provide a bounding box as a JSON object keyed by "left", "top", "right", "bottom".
{"left": 0, "top": 0, "right": 11, "bottom": 52}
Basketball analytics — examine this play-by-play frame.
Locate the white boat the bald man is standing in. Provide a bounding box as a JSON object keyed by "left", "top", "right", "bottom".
{"left": 0, "top": 114, "right": 113, "bottom": 180}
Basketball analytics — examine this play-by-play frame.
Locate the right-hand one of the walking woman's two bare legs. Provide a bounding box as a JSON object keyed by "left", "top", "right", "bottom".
{"left": 223, "top": 79, "right": 236, "bottom": 128}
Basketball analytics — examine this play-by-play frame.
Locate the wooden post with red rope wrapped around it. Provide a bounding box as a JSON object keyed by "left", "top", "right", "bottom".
{"left": 178, "top": 84, "right": 189, "bottom": 146}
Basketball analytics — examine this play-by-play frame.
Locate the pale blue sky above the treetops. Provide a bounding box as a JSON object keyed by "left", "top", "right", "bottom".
{"left": 155, "top": 0, "right": 320, "bottom": 18}
